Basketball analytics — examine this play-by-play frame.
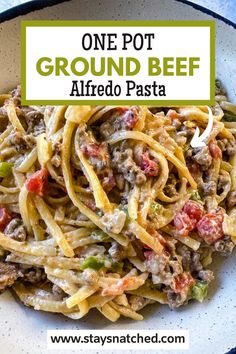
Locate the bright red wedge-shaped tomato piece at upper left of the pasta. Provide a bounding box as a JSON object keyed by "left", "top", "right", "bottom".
{"left": 25, "top": 168, "right": 48, "bottom": 197}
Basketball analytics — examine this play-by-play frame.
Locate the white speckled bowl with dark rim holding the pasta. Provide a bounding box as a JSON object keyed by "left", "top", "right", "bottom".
{"left": 0, "top": 0, "right": 236, "bottom": 354}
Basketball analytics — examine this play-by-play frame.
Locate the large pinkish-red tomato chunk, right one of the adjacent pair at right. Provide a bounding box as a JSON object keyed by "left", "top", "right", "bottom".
{"left": 197, "top": 211, "right": 224, "bottom": 245}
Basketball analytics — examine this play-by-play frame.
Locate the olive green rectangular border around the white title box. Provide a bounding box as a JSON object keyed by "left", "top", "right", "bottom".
{"left": 21, "top": 20, "right": 215, "bottom": 106}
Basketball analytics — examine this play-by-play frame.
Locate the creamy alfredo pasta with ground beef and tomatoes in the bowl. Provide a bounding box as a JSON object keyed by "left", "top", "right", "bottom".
{"left": 0, "top": 81, "right": 236, "bottom": 321}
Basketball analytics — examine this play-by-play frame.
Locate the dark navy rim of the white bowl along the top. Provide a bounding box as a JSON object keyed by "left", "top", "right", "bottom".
{"left": 0, "top": 0, "right": 236, "bottom": 29}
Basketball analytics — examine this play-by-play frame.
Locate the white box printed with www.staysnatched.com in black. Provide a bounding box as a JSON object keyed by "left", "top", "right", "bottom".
{"left": 47, "top": 330, "right": 189, "bottom": 350}
